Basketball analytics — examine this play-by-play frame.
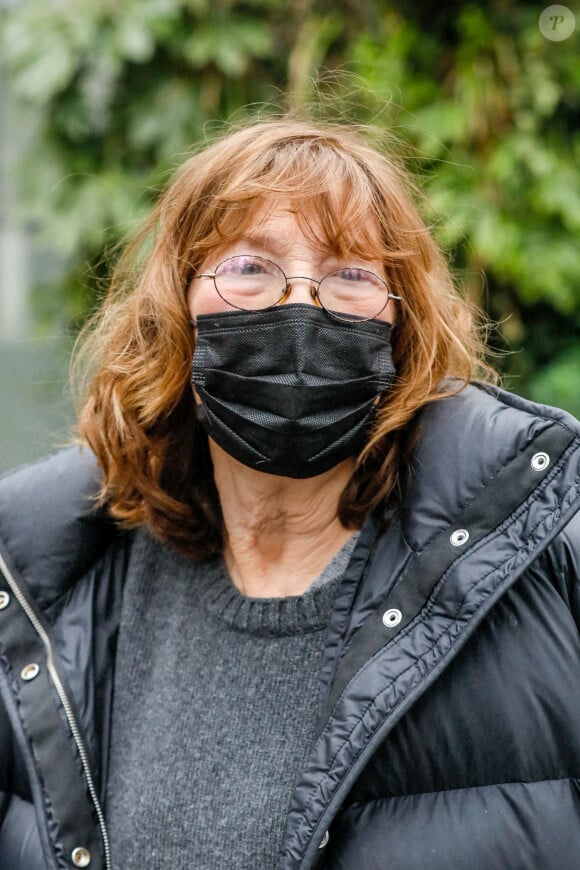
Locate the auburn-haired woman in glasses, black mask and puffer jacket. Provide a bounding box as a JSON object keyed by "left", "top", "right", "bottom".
{"left": 0, "top": 119, "right": 580, "bottom": 870}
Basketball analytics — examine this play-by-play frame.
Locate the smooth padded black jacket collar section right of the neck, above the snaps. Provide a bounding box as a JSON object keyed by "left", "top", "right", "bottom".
{"left": 402, "top": 384, "right": 580, "bottom": 551}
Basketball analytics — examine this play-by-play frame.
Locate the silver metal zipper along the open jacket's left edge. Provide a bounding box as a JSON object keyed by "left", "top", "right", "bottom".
{"left": 0, "top": 553, "right": 112, "bottom": 870}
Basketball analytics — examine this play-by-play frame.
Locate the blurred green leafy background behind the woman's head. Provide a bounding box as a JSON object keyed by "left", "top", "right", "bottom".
{"left": 0, "top": 0, "right": 580, "bottom": 470}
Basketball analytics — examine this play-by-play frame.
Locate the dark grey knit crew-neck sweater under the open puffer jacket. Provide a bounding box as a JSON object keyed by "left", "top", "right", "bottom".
{"left": 107, "top": 532, "right": 355, "bottom": 870}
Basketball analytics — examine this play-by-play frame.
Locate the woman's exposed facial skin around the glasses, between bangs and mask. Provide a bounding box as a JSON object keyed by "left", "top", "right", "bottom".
{"left": 188, "top": 205, "right": 396, "bottom": 323}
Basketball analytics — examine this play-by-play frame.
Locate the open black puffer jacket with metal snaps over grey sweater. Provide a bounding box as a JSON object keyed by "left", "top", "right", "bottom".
{"left": 0, "top": 387, "right": 580, "bottom": 870}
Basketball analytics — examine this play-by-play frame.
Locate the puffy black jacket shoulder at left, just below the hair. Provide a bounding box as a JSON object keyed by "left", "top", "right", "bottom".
{"left": 0, "top": 447, "right": 117, "bottom": 605}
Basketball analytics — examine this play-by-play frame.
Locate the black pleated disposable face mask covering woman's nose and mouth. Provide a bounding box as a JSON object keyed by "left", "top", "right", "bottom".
{"left": 192, "top": 303, "right": 395, "bottom": 478}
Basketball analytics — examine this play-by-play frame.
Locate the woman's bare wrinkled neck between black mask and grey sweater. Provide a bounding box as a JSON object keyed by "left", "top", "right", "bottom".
{"left": 210, "top": 440, "right": 353, "bottom": 598}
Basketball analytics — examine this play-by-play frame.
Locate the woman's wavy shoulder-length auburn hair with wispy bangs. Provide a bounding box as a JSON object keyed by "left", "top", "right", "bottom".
{"left": 73, "top": 117, "right": 493, "bottom": 559}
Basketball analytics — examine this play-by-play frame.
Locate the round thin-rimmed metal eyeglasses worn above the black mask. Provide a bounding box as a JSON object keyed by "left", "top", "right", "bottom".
{"left": 194, "top": 254, "right": 401, "bottom": 322}
